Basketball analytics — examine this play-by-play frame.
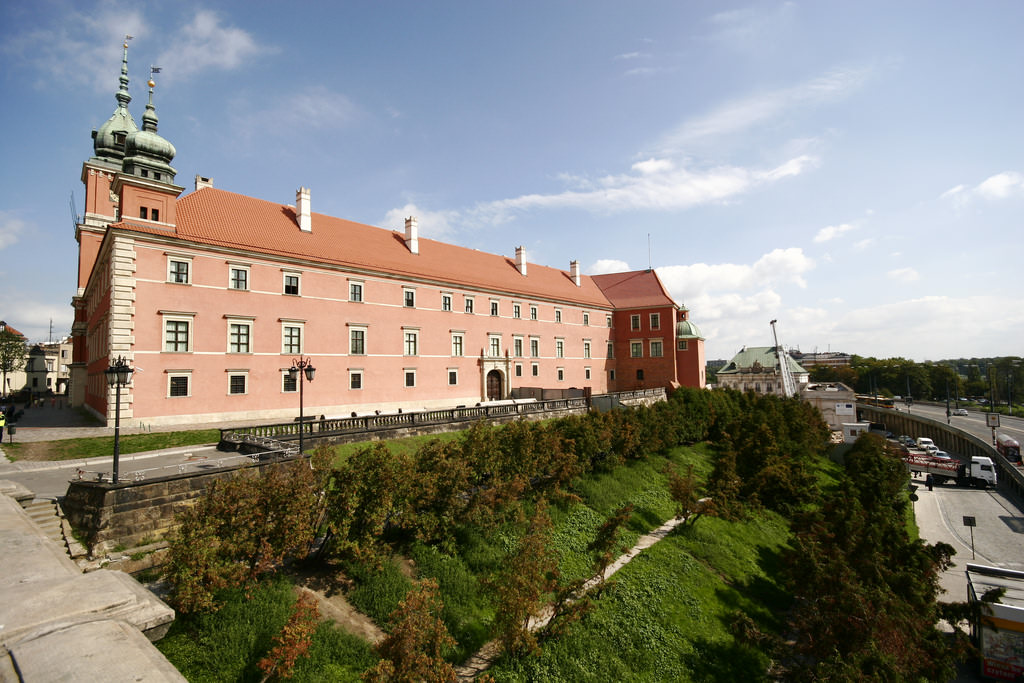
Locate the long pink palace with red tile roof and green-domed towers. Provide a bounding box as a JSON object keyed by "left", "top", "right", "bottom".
{"left": 71, "top": 47, "right": 703, "bottom": 424}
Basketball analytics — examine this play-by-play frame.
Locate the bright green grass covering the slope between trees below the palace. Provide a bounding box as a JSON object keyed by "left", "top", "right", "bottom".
{"left": 153, "top": 438, "right": 828, "bottom": 681}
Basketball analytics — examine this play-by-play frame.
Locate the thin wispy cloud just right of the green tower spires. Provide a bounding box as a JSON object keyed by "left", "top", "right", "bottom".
{"left": 158, "top": 9, "right": 269, "bottom": 80}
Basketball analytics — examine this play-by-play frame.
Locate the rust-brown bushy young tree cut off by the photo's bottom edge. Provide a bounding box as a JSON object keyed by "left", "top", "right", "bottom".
{"left": 362, "top": 579, "right": 456, "bottom": 683}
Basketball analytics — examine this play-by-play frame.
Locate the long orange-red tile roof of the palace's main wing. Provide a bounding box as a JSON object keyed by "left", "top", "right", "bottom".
{"left": 116, "top": 187, "right": 618, "bottom": 308}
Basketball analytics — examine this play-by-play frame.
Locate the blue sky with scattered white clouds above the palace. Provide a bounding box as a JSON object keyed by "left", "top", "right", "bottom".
{"left": 0, "top": 0, "right": 1024, "bottom": 360}
